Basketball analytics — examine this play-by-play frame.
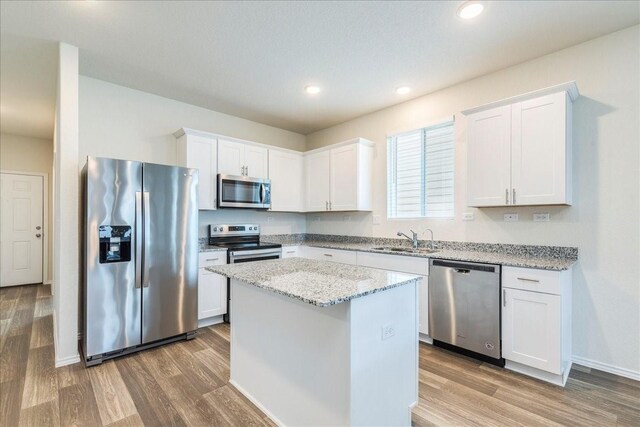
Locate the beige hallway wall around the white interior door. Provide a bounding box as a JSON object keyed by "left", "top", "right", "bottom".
{"left": 0, "top": 133, "right": 53, "bottom": 282}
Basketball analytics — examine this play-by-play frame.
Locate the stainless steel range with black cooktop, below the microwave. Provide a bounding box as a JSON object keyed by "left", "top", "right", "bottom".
{"left": 209, "top": 224, "right": 282, "bottom": 322}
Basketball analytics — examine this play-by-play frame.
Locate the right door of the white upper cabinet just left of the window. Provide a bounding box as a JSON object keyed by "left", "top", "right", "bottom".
{"left": 329, "top": 144, "right": 358, "bottom": 211}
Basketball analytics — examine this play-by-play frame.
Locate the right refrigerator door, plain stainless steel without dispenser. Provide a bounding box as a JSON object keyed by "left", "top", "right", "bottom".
{"left": 142, "top": 163, "right": 198, "bottom": 343}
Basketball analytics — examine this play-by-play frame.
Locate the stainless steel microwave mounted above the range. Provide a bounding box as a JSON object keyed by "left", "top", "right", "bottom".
{"left": 218, "top": 174, "right": 271, "bottom": 209}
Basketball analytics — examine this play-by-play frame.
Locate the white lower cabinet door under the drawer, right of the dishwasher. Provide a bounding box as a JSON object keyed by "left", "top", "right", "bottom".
{"left": 502, "top": 288, "right": 562, "bottom": 375}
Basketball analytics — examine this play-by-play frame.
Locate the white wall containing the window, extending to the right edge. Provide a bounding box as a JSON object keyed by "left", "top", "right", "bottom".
{"left": 307, "top": 26, "right": 640, "bottom": 375}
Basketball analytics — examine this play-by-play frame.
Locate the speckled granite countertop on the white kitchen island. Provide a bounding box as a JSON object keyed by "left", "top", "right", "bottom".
{"left": 206, "top": 258, "right": 422, "bottom": 307}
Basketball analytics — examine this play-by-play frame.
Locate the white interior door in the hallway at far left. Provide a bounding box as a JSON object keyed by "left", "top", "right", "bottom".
{"left": 0, "top": 173, "right": 44, "bottom": 286}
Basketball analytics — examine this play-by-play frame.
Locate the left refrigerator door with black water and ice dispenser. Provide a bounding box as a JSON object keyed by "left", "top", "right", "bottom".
{"left": 83, "top": 157, "right": 142, "bottom": 358}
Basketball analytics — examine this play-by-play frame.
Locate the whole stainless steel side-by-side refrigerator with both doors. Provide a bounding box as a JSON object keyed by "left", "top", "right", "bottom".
{"left": 82, "top": 157, "right": 198, "bottom": 366}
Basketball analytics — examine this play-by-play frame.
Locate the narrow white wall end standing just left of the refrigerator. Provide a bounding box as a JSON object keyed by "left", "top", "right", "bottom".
{"left": 53, "top": 43, "right": 80, "bottom": 367}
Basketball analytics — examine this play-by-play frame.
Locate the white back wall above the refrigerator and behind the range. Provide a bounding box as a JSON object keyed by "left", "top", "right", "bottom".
{"left": 79, "top": 76, "right": 305, "bottom": 237}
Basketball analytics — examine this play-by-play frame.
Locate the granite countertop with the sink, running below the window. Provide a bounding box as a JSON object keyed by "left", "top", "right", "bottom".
{"left": 263, "top": 235, "right": 578, "bottom": 271}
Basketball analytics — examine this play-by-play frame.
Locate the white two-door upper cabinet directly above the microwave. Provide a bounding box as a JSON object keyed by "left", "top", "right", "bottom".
{"left": 218, "top": 138, "right": 268, "bottom": 178}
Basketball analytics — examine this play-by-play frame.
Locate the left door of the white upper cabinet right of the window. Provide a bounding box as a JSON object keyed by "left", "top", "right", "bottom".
{"left": 467, "top": 105, "right": 511, "bottom": 206}
